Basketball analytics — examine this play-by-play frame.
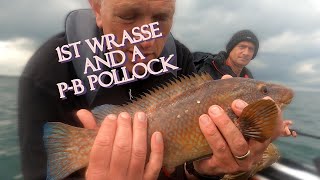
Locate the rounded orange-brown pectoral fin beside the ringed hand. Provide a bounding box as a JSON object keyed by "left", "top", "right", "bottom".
{"left": 237, "top": 99, "right": 278, "bottom": 142}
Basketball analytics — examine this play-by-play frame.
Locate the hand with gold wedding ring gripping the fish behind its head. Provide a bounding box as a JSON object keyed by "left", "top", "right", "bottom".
{"left": 194, "top": 100, "right": 270, "bottom": 175}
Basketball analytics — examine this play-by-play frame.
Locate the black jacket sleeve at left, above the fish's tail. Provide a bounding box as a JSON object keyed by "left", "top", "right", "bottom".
{"left": 18, "top": 34, "right": 83, "bottom": 179}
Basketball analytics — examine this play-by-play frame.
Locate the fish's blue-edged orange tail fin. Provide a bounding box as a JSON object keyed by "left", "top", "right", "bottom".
{"left": 43, "top": 122, "right": 97, "bottom": 180}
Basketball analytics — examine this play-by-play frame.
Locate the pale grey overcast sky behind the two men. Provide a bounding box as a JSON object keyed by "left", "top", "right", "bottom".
{"left": 0, "top": 0, "right": 320, "bottom": 92}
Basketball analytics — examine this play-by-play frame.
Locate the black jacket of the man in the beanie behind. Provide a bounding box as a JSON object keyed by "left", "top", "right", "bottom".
{"left": 193, "top": 51, "right": 253, "bottom": 79}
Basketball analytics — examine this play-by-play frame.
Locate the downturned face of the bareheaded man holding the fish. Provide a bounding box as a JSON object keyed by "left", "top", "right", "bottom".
{"left": 94, "top": 0, "right": 175, "bottom": 71}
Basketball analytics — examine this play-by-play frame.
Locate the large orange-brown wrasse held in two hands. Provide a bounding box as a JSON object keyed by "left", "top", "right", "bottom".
{"left": 44, "top": 74, "right": 293, "bottom": 179}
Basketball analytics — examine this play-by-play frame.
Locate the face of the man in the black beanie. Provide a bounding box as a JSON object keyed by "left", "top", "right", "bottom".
{"left": 229, "top": 41, "right": 255, "bottom": 68}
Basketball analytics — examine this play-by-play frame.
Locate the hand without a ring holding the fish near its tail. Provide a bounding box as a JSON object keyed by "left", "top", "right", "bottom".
{"left": 77, "top": 110, "right": 164, "bottom": 179}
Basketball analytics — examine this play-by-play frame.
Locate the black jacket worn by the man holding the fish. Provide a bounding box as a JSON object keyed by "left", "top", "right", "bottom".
{"left": 18, "top": 30, "right": 195, "bottom": 179}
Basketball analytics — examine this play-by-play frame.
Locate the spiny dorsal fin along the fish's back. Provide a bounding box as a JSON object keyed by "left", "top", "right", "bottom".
{"left": 132, "top": 73, "right": 213, "bottom": 109}
